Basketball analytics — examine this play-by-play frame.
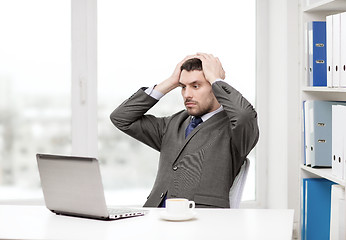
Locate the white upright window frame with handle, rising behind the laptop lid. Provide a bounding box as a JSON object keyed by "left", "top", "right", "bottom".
{"left": 71, "top": 0, "right": 98, "bottom": 157}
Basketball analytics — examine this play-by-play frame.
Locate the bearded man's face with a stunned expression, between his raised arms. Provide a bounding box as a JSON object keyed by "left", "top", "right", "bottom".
{"left": 179, "top": 70, "right": 220, "bottom": 116}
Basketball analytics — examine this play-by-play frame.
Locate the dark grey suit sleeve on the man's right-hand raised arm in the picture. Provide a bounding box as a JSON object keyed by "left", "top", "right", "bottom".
{"left": 212, "top": 81, "right": 259, "bottom": 157}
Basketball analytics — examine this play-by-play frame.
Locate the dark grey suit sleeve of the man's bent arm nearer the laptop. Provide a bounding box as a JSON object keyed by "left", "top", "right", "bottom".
{"left": 110, "top": 89, "right": 167, "bottom": 151}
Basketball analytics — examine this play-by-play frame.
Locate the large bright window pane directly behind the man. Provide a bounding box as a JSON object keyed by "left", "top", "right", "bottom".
{"left": 98, "top": 0, "right": 256, "bottom": 204}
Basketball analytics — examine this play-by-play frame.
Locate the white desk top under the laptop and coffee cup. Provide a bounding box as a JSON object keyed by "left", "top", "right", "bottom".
{"left": 0, "top": 205, "right": 293, "bottom": 240}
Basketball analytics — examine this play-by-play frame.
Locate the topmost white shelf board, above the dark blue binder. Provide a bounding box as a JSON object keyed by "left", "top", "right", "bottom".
{"left": 303, "top": 0, "right": 346, "bottom": 13}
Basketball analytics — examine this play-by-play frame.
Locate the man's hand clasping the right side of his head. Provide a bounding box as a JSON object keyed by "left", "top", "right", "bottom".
{"left": 196, "top": 53, "right": 225, "bottom": 84}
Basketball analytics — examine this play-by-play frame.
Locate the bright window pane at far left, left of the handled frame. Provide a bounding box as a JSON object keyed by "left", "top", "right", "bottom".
{"left": 0, "top": 0, "right": 71, "bottom": 199}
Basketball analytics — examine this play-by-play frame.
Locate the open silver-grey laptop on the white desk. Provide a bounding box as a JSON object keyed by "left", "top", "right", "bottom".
{"left": 36, "top": 154, "right": 148, "bottom": 220}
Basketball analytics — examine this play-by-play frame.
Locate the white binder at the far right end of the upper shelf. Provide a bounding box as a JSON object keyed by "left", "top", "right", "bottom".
{"left": 340, "top": 12, "right": 346, "bottom": 87}
